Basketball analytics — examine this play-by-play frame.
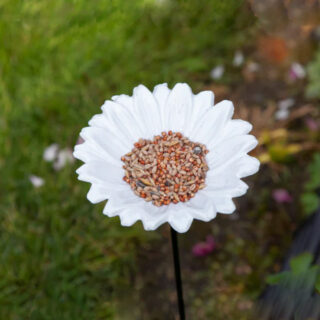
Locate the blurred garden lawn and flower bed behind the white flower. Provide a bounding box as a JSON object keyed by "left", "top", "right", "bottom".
{"left": 0, "top": 0, "right": 320, "bottom": 320}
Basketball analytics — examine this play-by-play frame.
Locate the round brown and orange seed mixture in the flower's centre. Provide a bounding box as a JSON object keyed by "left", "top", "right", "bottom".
{"left": 121, "top": 131, "right": 209, "bottom": 207}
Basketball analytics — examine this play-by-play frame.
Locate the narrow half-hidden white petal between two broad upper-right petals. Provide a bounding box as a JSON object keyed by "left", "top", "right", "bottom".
{"left": 185, "top": 91, "right": 214, "bottom": 137}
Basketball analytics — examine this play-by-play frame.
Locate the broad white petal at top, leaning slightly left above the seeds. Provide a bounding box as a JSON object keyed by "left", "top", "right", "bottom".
{"left": 133, "top": 85, "right": 161, "bottom": 139}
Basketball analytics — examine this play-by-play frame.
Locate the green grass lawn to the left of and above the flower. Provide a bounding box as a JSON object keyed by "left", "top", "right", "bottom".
{"left": 0, "top": 0, "right": 252, "bottom": 320}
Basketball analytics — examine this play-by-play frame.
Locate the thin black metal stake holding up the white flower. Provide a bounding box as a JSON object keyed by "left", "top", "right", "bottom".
{"left": 170, "top": 227, "right": 186, "bottom": 320}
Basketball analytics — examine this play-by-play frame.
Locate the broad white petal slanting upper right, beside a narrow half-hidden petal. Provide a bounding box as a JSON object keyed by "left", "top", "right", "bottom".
{"left": 190, "top": 100, "right": 234, "bottom": 146}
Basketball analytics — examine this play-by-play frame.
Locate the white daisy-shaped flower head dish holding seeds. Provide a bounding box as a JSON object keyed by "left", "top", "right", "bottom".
{"left": 74, "top": 83, "right": 259, "bottom": 232}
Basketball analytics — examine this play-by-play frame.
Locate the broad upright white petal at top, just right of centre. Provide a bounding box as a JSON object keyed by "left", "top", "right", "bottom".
{"left": 164, "top": 83, "right": 193, "bottom": 133}
